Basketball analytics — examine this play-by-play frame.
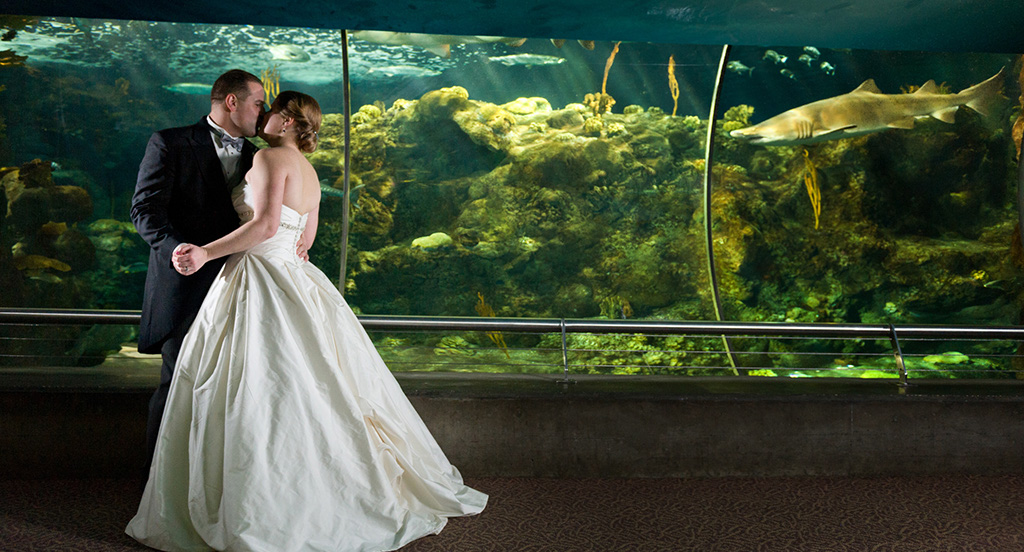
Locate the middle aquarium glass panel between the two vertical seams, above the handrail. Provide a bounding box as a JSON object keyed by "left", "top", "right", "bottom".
{"left": 342, "top": 32, "right": 720, "bottom": 319}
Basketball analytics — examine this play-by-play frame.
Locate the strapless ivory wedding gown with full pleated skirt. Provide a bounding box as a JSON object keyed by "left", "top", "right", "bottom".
{"left": 126, "top": 182, "right": 487, "bottom": 552}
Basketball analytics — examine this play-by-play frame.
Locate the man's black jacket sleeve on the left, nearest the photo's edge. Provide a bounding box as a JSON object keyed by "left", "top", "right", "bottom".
{"left": 131, "top": 132, "right": 183, "bottom": 266}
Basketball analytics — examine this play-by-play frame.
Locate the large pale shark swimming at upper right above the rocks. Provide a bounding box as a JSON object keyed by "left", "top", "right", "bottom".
{"left": 729, "top": 68, "right": 1006, "bottom": 145}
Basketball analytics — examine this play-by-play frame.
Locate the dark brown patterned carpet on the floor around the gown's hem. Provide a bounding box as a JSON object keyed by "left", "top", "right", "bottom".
{"left": 0, "top": 476, "right": 1024, "bottom": 552}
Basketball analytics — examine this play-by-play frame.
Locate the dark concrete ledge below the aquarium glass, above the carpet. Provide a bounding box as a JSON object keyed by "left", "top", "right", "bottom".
{"left": 0, "top": 374, "right": 1024, "bottom": 478}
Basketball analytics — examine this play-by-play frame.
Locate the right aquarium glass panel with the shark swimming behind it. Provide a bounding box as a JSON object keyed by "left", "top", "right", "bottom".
{"left": 712, "top": 46, "right": 1024, "bottom": 373}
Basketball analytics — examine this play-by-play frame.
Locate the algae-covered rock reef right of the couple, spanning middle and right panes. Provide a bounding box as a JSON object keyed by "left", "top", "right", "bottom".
{"left": 313, "top": 87, "right": 1021, "bottom": 376}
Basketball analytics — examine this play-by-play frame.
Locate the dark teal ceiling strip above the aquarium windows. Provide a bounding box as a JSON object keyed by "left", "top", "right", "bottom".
{"left": 6, "top": 0, "right": 1024, "bottom": 53}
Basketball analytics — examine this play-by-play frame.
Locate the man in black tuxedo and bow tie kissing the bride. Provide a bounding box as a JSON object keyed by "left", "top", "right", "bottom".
{"left": 131, "top": 70, "right": 264, "bottom": 475}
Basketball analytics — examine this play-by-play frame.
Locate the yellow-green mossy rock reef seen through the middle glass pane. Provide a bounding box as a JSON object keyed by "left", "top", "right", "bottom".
{"left": 313, "top": 87, "right": 720, "bottom": 316}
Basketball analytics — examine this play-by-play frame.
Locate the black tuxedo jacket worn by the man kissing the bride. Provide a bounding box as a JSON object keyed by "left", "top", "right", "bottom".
{"left": 131, "top": 117, "right": 256, "bottom": 353}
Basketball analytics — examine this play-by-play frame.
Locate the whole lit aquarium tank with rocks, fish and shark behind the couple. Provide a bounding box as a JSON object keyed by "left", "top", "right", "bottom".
{"left": 0, "top": 10, "right": 1024, "bottom": 379}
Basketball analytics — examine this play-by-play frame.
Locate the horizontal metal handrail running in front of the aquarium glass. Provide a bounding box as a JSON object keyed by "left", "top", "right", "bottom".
{"left": 0, "top": 308, "right": 1024, "bottom": 341}
